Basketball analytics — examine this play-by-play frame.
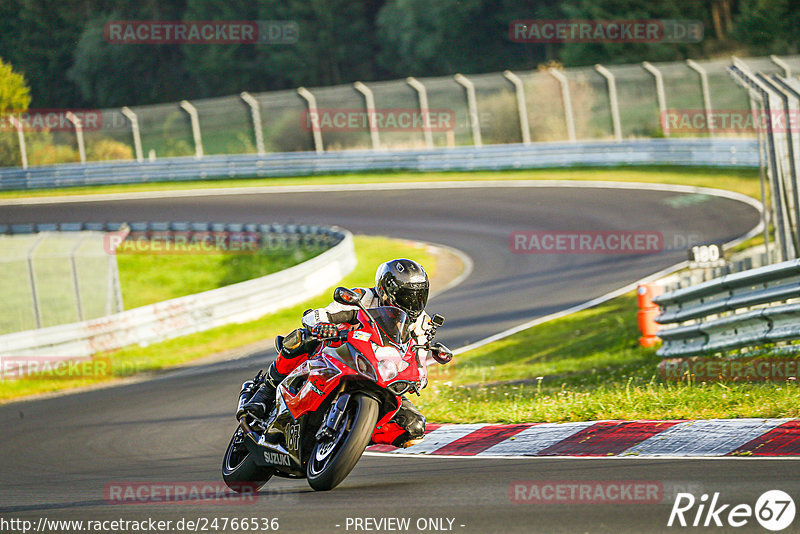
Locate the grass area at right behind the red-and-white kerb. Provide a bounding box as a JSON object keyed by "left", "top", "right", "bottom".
{"left": 417, "top": 294, "right": 800, "bottom": 423}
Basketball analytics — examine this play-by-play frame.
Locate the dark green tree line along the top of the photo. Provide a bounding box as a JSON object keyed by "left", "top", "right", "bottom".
{"left": 0, "top": 0, "right": 800, "bottom": 108}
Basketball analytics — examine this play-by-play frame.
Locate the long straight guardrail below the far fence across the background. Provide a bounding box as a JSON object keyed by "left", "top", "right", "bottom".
{"left": 0, "top": 138, "right": 759, "bottom": 190}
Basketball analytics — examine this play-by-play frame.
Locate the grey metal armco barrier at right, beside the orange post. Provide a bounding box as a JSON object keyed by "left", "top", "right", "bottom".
{"left": 653, "top": 260, "right": 800, "bottom": 358}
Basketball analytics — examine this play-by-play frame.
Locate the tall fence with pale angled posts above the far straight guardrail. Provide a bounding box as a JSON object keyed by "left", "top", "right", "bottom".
{"left": 0, "top": 56, "right": 800, "bottom": 166}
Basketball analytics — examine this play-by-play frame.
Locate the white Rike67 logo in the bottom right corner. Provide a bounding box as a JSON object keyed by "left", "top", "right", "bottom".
{"left": 667, "top": 490, "right": 795, "bottom": 532}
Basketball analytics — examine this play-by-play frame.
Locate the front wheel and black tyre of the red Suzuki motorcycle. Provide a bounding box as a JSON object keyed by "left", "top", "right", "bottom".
{"left": 306, "top": 394, "right": 378, "bottom": 491}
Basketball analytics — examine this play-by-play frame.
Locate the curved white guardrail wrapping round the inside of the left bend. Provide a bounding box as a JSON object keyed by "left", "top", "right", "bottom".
{"left": 0, "top": 223, "right": 356, "bottom": 360}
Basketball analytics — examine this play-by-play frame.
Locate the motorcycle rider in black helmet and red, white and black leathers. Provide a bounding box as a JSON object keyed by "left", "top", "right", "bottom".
{"left": 237, "top": 259, "right": 430, "bottom": 447}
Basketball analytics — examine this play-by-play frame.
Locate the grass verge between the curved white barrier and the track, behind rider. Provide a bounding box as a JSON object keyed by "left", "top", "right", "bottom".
{"left": 0, "top": 236, "right": 436, "bottom": 402}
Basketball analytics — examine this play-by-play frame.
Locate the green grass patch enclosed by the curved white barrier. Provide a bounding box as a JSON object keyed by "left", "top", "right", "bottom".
{"left": 117, "top": 248, "right": 321, "bottom": 309}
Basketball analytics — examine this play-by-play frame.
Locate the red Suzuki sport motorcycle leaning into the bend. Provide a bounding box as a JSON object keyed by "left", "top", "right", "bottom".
{"left": 222, "top": 287, "right": 453, "bottom": 492}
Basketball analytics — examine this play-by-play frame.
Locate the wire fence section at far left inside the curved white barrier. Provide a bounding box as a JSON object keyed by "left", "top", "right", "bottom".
{"left": 0, "top": 232, "right": 123, "bottom": 334}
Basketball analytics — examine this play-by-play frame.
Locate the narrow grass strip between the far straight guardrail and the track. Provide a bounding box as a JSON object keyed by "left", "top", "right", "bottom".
{"left": 0, "top": 165, "right": 760, "bottom": 199}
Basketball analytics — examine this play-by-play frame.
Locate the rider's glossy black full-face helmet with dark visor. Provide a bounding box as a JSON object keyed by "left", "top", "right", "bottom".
{"left": 375, "top": 259, "right": 430, "bottom": 320}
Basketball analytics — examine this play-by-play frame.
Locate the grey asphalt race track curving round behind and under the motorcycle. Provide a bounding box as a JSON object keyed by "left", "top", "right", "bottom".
{"left": 0, "top": 183, "right": 800, "bottom": 533}
